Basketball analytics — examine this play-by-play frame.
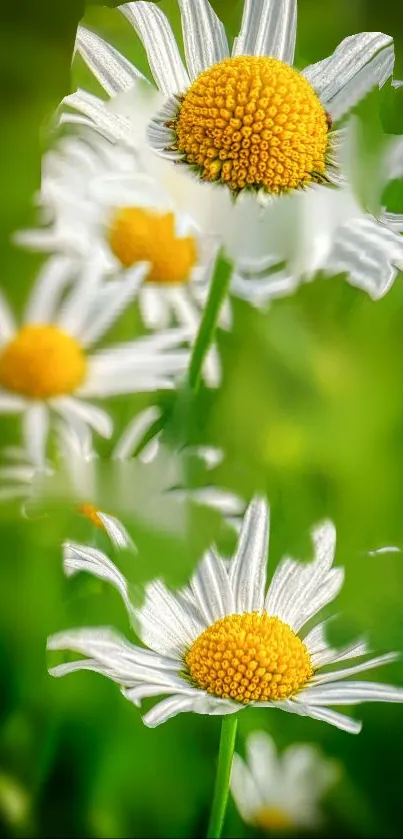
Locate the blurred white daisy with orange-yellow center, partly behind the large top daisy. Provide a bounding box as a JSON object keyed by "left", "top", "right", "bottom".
{"left": 15, "top": 131, "right": 230, "bottom": 386}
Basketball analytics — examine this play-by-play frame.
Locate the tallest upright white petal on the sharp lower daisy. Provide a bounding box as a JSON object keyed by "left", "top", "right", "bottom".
{"left": 229, "top": 497, "right": 269, "bottom": 613}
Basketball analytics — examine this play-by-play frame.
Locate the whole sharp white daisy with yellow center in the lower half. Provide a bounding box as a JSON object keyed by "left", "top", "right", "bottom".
{"left": 48, "top": 499, "right": 403, "bottom": 733}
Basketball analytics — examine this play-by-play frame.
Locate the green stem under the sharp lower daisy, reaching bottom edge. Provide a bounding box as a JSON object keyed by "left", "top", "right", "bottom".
{"left": 207, "top": 714, "right": 238, "bottom": 839}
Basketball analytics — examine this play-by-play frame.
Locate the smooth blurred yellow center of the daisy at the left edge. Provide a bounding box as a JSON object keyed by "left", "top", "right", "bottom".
{"left": 0, "top": 324, "right": 87, "bottom": 399}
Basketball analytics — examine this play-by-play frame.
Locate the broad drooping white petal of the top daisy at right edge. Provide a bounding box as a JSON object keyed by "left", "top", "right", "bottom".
{"left": 324, "top": 216, "right": 403, "bottom": 300}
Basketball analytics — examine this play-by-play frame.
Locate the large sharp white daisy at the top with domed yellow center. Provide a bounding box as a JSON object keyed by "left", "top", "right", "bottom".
{"left": 62, "top": 0, "right": 403, "bottom": 302}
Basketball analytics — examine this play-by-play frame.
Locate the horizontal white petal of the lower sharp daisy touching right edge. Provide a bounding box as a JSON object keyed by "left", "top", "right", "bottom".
{"left": 298, "top": 673, "right": 403, "bottom": 705}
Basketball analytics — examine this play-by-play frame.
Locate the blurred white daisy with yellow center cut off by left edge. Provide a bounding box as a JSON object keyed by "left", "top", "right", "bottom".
{"left": 0, "top": 257, "right": 189, "bottom": 464}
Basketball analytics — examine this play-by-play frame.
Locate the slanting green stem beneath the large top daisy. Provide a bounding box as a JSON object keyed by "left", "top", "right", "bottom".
{"left": 188, "top": 251, "right": 232, "bottom": 393}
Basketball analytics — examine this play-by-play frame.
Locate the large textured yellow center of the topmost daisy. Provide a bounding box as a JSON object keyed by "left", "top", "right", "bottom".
{"left": 175, "top": 55, "right": 329, "bottom": 193}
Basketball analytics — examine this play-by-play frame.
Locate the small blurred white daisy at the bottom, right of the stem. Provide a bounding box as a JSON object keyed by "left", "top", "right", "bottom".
{"left": 231, "top": 731, "right": 339, "bottom": 833}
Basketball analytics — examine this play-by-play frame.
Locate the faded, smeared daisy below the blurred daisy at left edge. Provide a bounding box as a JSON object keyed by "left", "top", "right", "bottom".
{"left": 0, "top": 406, "right": 245, "bottom": 549}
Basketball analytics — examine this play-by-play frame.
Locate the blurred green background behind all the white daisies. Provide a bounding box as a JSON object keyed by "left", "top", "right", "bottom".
{"left": 0, "top": 0, "right": 403, "bottom": 837}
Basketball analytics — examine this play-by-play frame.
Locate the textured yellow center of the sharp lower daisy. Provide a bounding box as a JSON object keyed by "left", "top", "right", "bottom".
{"left": 185, "top": 612, "right": 313, "bottom": 704}
